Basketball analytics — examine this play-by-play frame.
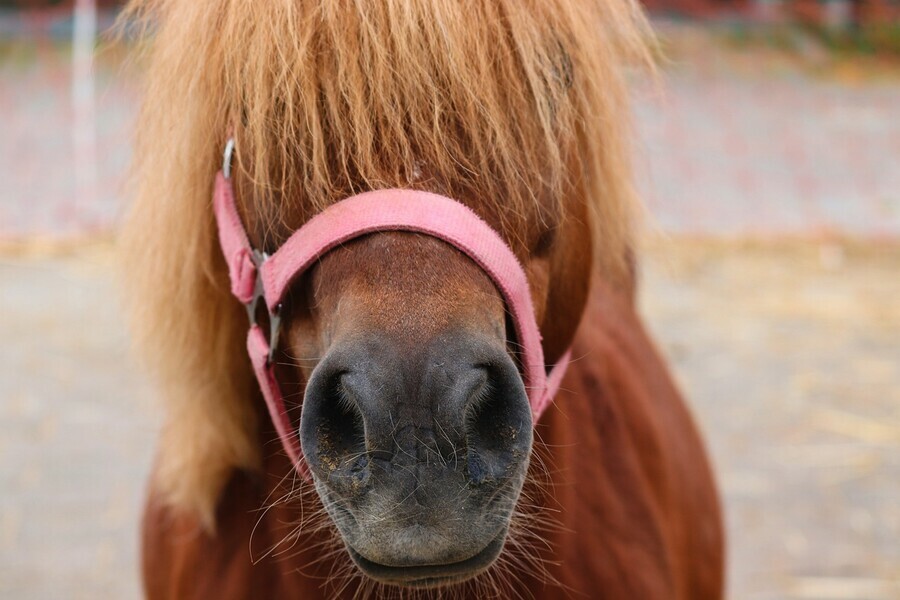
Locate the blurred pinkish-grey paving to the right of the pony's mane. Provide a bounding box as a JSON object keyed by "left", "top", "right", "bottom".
{"left": 636, "top": 56, "right": 900, "bottom": 238}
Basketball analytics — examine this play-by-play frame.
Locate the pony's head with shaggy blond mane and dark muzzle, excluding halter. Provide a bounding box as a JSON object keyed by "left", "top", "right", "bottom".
{"left": 123, "top": 0, "right": 646, "bottom": 586}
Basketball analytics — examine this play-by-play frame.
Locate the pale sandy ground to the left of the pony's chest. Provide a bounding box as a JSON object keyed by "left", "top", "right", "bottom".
{"left": 0, "top": 243, "right": 156, "bottom": 600}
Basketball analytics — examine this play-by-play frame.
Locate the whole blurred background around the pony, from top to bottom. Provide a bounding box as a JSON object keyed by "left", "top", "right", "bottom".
{"left": 0, "top": 0, "right": 900, "bottom": 600}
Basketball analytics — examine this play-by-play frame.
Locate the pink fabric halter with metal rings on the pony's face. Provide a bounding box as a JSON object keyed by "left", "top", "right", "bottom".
{"left": 213, "top": 141, "right": 571, "bottom": 477}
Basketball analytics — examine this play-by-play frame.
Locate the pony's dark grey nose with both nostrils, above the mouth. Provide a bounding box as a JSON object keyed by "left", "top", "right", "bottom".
{"left": 300, "top": 336, "right": 532, "bottom": 485}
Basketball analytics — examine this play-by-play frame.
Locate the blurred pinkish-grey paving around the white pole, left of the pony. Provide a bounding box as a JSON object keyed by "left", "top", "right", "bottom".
{"left": 0, "top": 40, "right": 138, "bottom": 240}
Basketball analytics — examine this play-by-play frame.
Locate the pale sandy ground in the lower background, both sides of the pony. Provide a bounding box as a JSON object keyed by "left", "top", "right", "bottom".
{"left": 0, "top": 240, "right": 900, "bottom": 600}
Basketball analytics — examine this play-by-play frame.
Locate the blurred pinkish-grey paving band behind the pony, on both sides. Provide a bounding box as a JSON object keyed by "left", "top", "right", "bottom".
{"left": 0, "top": 30, "right": 900, "bottom": 240}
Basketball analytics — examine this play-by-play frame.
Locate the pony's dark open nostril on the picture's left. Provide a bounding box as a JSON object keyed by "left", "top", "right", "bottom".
{"left": 301, "top": 371, "right": 366, "bottom": 472}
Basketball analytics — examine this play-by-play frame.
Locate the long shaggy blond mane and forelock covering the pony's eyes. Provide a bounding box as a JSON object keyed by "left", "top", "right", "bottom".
{"left": 122, "top": 0, "right": 649, "bottom": 526}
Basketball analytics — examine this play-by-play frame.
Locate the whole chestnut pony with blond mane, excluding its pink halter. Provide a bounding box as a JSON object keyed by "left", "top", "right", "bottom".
{"left": 120, "top": 0, "right": 724, "bottom": 599}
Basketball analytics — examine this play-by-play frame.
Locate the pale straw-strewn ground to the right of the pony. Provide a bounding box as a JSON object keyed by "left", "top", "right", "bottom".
{"left": 641, "top": 242, "right": 900, "bottom": 600}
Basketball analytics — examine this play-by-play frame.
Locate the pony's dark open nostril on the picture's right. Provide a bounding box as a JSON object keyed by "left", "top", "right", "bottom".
{"left": 466, "top": 368, "right": 531, "bottom": 484}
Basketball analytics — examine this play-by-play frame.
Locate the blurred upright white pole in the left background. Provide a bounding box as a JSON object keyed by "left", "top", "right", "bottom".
{"left": 72, "top": 0, "right": 97, "bottom": 230}
